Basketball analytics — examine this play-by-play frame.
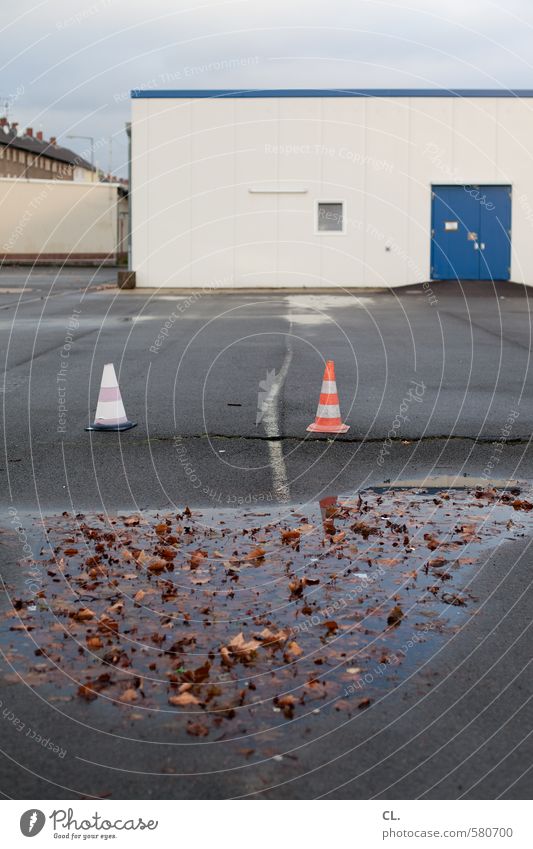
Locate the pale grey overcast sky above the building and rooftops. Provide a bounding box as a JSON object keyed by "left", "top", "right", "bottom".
{"left": 0, "top": 0, "right": 533, "bottom": 174}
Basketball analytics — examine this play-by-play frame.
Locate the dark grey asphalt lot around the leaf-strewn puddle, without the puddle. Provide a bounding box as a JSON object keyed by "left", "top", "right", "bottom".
{"left": 0, "top": 269, "right": 533, "bottom": 798}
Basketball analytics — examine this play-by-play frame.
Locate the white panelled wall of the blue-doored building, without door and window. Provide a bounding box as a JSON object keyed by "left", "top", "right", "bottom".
{"left": 132, "top": 97, "right": 533, "bottom": 287}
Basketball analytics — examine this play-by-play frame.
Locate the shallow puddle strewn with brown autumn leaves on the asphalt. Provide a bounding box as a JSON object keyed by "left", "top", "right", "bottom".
{"left": 0, "top": 479, "right": 533, "bottom": 741}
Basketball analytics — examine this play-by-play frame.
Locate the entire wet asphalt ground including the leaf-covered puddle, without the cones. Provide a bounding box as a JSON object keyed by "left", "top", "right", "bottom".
{"left": 0, "top": 269, "right": 533, "bottom": 798}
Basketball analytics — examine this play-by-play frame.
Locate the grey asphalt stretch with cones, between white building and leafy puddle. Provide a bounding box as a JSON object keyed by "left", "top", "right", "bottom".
{"left": 0, "top": 270, "right": 533, "bottom": 511}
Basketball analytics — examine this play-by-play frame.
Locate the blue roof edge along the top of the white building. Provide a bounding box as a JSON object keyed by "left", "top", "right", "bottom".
{"left": 131, "top": 88, "right": 533, "bottom": 99}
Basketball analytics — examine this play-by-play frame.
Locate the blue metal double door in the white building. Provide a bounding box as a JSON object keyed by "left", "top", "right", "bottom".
{"left": 431, "top": 186, "right": 511, "bottom": 280}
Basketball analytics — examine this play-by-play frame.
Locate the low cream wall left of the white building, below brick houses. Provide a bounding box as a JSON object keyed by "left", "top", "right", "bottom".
{"left": 0, "top": 179, "right": 117, "bottom": 261}
